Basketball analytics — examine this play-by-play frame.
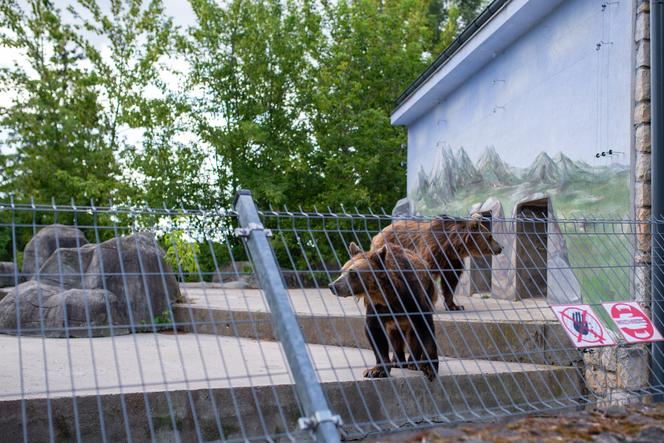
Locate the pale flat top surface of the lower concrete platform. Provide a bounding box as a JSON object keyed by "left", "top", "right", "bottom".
{"left": 0, "top": 333, "right": 572, "bottom": 402}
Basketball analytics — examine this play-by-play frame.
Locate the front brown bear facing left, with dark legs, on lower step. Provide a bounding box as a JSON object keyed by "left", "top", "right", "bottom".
{"left": 329, "top": 243, "right": 438, "bottom": 380}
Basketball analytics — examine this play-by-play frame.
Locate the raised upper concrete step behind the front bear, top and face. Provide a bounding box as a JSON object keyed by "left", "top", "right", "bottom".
{"left": 174, "top": 284, "right": 581, "bottom": 366}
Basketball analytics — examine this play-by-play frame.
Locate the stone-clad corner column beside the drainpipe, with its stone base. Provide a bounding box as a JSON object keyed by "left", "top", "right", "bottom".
{"left": 584, "top": 0, "right": 651, "bottom": 401}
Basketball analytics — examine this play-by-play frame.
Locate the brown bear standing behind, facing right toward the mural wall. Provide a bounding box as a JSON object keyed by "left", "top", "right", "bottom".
{"left": 371, "top": 215, "right": 503, "bottom": 311}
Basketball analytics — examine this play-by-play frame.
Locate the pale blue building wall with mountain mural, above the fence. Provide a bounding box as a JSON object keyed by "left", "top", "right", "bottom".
{"left": 408, "top": 0, "right": 632, "bottom": 217}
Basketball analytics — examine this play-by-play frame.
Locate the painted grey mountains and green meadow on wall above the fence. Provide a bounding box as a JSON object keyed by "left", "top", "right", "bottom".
{"left": 410, "top": 146, "right": 630, "bottom": 218}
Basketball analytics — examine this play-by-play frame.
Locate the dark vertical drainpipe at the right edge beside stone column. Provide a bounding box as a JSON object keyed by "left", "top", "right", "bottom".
{"left": 650, "top": 0, "right": 664, "bottom": 401}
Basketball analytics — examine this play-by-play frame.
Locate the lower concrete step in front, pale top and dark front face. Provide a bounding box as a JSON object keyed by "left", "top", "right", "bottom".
{"left": 0, "top": 332, "right": 582, "bottom": 441}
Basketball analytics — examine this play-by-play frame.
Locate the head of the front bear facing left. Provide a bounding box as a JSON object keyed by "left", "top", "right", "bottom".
{"left": 328, "top": 242, "right": 387, "bottom": 297}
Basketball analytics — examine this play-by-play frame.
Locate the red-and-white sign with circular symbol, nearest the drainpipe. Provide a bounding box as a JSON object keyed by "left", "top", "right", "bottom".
{"left": 602, "top": 301, "right": 664, "bottom": 343}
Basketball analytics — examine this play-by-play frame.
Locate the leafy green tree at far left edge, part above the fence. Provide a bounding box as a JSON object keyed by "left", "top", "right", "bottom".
{"left": 0, "top": 0, "right": 118, "bottom": 203}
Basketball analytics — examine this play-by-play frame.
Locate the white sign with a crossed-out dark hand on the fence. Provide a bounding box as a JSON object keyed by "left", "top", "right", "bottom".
{"left": 551, "top": 305, "right": 616, "bottom": 348}
